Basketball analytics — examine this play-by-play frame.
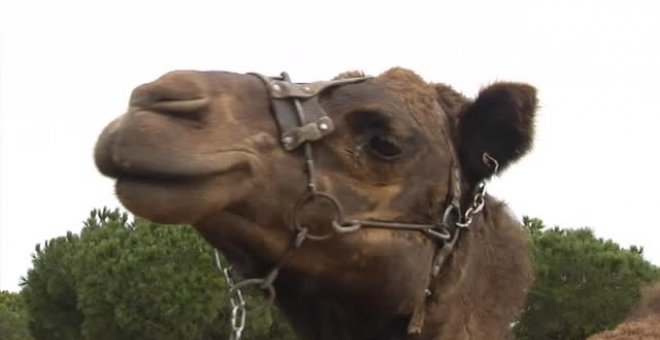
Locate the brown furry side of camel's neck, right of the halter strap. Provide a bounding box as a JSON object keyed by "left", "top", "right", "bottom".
{"left": 420, "top": 198, "right": 532, "bottom": 339}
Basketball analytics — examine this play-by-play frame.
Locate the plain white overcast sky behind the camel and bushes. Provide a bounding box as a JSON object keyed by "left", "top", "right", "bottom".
{"left": 0, "top": 0, "right": 660, "bottom": 290}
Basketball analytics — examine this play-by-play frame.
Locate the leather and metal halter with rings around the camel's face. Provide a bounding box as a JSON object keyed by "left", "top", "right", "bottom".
{"left": 240, "top": 72, "right": 476, "bottom": 334}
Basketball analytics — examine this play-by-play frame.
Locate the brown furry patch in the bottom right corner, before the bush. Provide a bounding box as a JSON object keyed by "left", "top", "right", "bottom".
{"left": 589, "top": 283, "right": 660, "bottom": 340}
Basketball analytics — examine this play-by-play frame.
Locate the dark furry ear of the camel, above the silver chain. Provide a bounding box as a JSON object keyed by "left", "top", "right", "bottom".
{"left": 458, "top": 83, "right": 537, "bottom": 181}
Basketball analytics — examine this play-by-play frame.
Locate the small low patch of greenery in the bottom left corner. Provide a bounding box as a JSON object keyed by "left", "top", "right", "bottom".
{"left": 0, "top": 291, "right": 32, "bottom": 340}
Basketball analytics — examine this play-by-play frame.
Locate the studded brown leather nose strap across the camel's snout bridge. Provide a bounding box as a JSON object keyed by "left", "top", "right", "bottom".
{"left": 249, "top": 72, "right": 369, "bottom": 151}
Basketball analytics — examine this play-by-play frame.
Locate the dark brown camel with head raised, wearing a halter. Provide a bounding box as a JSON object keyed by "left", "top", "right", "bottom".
{"left": 95, "top": 67, "right": 537, "bottom": 340}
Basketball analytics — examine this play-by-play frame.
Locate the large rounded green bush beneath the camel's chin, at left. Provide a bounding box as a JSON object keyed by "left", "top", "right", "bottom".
{"left": 22, "top": 209, "right": 294, "bottom": 340}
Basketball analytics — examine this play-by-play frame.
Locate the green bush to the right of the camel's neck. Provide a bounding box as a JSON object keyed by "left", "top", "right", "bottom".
{"left": 515, "top": 217, "right": 660, "bottom": 340}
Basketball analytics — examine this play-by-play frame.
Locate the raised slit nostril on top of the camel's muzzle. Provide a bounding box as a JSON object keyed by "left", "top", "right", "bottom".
{"left": 130, "top": 71, "right": 209, "bottom": 114}
